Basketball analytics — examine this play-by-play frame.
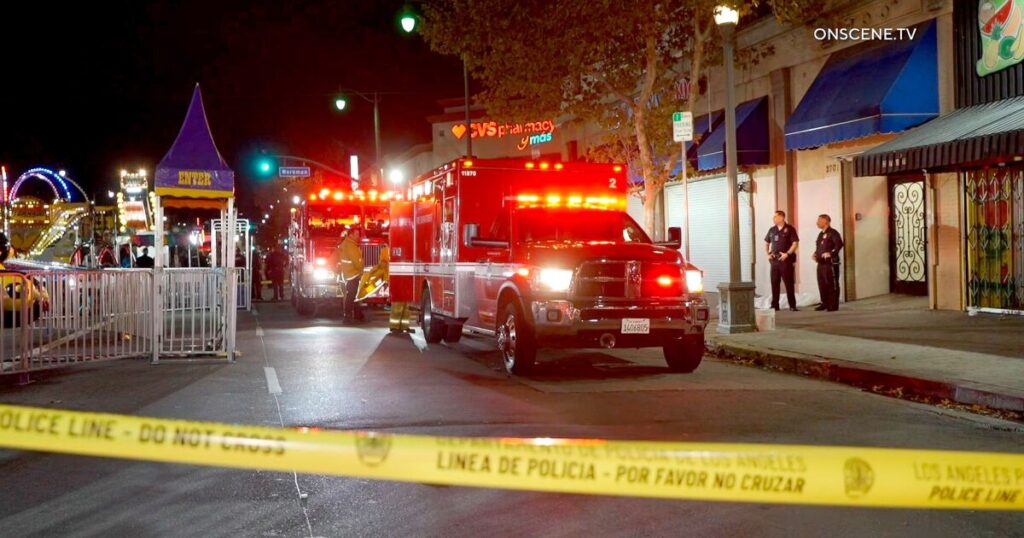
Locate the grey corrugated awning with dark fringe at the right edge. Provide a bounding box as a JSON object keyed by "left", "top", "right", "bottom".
{"left": 853, "top": 96, "right": 1024, "bottom": 176}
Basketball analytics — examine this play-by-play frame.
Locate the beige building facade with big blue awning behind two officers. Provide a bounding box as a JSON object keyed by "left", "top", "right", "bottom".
{"left": 659, "top": 0, "right": 956, "bottom": 307}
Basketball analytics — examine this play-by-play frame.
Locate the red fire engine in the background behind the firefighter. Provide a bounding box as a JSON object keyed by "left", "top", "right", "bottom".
{"left": 289, "top": 185, "right": 394, "bottom": 316}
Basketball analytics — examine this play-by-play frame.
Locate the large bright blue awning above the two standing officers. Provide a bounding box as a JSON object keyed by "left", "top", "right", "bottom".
{"left": 785, "top": 22, "right": 939, "bottom": 150}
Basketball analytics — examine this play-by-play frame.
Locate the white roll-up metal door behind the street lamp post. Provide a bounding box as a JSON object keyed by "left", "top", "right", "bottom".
{"left": 680, "top": 176, "right": 753, "bottom": 292}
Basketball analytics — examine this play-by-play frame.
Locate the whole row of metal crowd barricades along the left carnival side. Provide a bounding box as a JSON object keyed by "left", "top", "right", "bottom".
{"left": 0, "top": 267, "right": 239, "bottom": 380}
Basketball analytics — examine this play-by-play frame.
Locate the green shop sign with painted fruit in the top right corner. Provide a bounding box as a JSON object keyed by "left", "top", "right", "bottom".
{"left": 977, "top": 0, "right": 1024, "bottom": 77}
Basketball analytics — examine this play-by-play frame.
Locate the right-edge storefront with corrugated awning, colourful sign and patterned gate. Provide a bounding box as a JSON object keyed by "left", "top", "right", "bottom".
{"left": 855, "top": 0, "right": 1024, "bottom": 314}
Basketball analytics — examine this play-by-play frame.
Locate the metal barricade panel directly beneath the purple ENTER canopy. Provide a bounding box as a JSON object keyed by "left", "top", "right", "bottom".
{"left": 159, "top": 267, "right": 239, "bottom": 359}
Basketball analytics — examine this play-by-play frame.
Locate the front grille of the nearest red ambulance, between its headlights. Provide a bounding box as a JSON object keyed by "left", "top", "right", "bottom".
{"left": 572, "top": 260, "right": 684, "bottom": 301}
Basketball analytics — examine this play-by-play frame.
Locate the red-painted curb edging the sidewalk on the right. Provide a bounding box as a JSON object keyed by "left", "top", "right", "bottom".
{"left": 707, "top": 339, "right": 1024, "bottom": 413}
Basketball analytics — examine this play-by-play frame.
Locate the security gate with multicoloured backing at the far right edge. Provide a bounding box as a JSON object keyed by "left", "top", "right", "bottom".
{"left": 964, "top": 166, "right": 1024, "bottom": 314}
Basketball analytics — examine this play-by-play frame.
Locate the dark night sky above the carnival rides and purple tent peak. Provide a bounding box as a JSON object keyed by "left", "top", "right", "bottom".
{"left": 0, "top": 0, "right": 462, "bottom": 214}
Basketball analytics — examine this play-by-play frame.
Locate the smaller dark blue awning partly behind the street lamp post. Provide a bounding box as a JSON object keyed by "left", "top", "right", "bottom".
{"left": 696, "top": 96, "right": 771, "bottom": 170}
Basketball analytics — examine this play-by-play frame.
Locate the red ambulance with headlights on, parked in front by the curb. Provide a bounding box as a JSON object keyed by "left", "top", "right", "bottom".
{"left": 390, "top": 159, "right": 708, "bottom": 373}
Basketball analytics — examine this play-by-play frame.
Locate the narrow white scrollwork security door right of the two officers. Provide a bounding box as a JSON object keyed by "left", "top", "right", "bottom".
{"left": 889, "top": 176, "right": 928, "bottom": 295}
